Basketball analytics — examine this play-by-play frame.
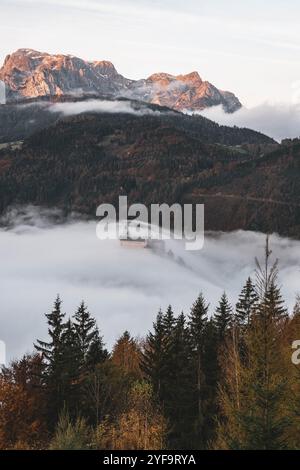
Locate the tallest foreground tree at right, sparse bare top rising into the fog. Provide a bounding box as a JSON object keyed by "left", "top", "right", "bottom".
{"left": 244, "top": 241, "right": 287, "bottom": 449}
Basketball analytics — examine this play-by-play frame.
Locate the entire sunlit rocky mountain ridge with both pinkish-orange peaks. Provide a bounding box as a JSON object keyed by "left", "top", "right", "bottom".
{"left": 0, "top": 49, "right": 241, "bottom": 112}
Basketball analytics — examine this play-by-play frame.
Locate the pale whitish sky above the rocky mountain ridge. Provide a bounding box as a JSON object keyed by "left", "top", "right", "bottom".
{"left": 0, "top": 0, "right": 300, "bottom": 106}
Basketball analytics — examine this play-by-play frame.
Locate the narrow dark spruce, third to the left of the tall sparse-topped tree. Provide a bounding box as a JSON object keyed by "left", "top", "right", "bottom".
{"left": 189, "top": 294, "right": 208, "bottom": 446}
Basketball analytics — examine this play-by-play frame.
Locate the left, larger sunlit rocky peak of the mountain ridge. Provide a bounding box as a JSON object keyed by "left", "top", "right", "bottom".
{"left": 0, "top": 49, "right": 131, "bottom": 101}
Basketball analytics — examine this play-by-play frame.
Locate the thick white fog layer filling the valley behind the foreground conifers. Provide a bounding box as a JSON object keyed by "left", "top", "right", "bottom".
{"left": 0, "top": 207, "right": 300, "bottom": 358}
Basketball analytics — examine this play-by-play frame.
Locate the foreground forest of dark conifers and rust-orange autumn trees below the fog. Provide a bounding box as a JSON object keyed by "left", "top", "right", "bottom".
{"left": 0, "top": 241, "right": 300, "bottom": 450}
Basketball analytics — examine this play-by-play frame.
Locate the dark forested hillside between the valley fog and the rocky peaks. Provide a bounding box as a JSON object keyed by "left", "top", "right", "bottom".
{"left": 0, "top": 108, "right": 300, "bottom": 237}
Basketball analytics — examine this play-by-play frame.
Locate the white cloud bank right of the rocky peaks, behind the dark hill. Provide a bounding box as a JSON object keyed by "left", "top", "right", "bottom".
{"left": 201, "top": 103, "right": 300, "bottom": 141}
